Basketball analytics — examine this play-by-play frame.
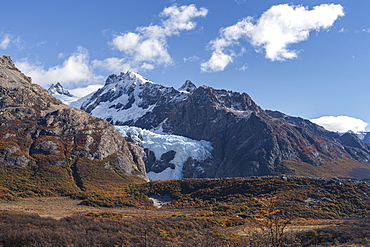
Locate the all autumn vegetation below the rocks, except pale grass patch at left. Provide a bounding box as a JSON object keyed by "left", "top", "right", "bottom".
{"left": 0, "top": 162, "right": 370, "bottom": 246}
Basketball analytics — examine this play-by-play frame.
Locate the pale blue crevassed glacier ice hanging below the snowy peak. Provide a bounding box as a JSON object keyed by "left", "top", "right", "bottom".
{"left": 116, "top": 126, "right": 213, "bottom": 180}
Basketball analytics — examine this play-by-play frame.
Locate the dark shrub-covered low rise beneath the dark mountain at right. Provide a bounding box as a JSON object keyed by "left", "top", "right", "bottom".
{"left": 137, "top": 177, "right": 370, "bottom": 219}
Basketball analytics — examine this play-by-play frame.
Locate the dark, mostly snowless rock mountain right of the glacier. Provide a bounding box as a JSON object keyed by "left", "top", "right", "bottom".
{"left": 163, "top": 87, "right": 370, "bottom": 177}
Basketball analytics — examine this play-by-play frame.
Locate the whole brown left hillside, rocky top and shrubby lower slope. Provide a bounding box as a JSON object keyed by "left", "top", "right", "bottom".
{"left": 0, "top": 56, "right": 147, "bottom": 201}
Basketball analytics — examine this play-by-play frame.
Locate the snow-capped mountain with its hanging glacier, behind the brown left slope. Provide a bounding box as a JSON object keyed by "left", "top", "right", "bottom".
{"left": 49, "top": 71, "right": 370, "bottom": 179}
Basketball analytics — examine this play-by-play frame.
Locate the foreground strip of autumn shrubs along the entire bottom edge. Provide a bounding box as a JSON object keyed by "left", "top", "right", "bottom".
{"left": 0, "top": 210, "right": 370, "bottom": 247}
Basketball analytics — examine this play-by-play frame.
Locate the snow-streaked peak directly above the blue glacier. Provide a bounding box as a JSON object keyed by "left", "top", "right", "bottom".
{"left": 75, "top": 71, "right": 191, "bottom": 126}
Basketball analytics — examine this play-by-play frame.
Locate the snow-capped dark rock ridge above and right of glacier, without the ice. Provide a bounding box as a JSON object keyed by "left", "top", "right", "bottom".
{"left": 76, "top": 72, "right": 370, "bottom": 178}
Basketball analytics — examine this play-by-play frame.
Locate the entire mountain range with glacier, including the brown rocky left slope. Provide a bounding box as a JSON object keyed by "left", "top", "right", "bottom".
{"left": 0, "top": 56, "right": 370, "bottom": 183}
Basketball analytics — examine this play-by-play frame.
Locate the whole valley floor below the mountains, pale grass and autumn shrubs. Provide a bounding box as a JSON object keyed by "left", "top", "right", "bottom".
{"left": 0, "top": 177, "right": 370, "bottom": 246}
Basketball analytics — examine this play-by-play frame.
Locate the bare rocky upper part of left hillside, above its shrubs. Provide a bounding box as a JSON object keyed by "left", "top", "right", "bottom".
{"left": 0, "top": 56, "right": 146, "bottom": 179}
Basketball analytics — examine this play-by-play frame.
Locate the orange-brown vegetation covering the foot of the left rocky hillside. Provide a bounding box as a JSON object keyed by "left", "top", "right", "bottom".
{"left": 0, "top": 157, "right": 149, "bottom": 207}
